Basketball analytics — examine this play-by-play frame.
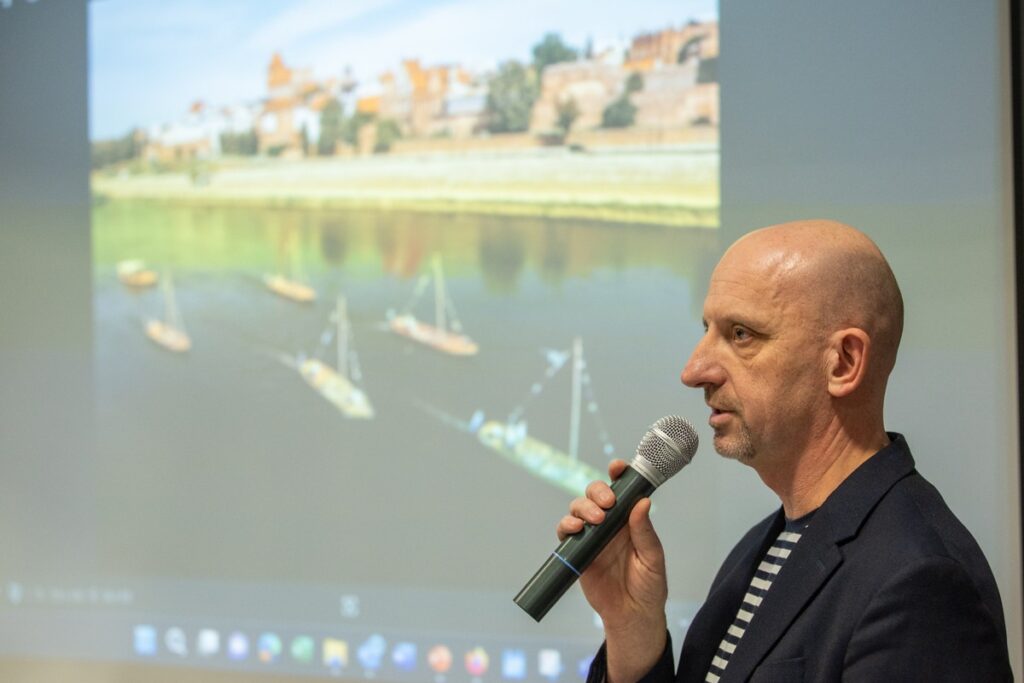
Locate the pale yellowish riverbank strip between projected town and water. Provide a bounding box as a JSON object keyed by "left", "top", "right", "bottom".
{"left": 92, "top": 143, "right": 719, "bottom": 227}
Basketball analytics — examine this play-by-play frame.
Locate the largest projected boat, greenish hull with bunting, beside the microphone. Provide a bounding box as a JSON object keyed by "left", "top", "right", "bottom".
{"left": 468, "top": 339, "right": 614, "bottom": 496}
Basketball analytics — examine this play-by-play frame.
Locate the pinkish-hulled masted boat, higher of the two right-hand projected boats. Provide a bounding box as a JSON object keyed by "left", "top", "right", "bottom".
{"left": 388, "top": 256, "right": 480, "bottom": 355}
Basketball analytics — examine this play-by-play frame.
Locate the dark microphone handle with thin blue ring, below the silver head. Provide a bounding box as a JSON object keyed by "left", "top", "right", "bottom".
{"left": 514, "top": 467, "right": 655, "bottom": 622}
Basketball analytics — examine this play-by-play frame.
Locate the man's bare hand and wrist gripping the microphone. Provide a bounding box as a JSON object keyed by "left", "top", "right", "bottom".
{"left": 557, "top": 460, "right": 669, "bottom": 683}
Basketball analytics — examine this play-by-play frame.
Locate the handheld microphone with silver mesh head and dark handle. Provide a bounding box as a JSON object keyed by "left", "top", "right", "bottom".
{"left": 514, "top": 415, "right": 697, "bottom": 622}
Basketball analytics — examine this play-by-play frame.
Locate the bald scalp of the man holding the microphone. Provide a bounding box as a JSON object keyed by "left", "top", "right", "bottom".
{"left": 722, "top": 220, "right": 903, "bottom": 388}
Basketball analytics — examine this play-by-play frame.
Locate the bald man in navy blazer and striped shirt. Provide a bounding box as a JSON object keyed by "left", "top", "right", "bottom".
{"left": 558, "top": 220, "right": 1013, "bottom": 683}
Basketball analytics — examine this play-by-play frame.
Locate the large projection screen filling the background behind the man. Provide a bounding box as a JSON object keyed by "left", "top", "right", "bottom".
{"left": 0, "top": 0, "right": 1022, "bottom": 683}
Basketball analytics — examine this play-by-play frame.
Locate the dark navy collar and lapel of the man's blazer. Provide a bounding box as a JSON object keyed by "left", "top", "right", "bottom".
{"left": 715, "top": 433, "right": 913, "bottom": 683}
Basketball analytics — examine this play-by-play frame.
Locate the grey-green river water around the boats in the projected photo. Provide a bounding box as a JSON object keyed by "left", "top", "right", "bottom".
{"left": 93, "top": 202, "right": 718, "bottom": 588}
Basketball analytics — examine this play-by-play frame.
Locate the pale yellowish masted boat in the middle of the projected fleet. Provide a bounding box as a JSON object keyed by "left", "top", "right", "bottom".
{"left": 295, "top": 296, "right": 374, "bottom": 420}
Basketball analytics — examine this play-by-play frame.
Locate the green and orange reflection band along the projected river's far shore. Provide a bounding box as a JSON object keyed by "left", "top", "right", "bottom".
{"left": 93, "top": 202, "right": 717, "bottom": 294}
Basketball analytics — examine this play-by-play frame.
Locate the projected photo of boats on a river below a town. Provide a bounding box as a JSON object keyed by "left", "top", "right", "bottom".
{"left": 89, "top": 0, "right": 720, "bottom": 679}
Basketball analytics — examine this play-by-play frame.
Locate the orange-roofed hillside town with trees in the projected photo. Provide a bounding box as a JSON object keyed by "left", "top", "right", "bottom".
{"left": 99, "top": 22, "right": 719, "bottom": 168}
